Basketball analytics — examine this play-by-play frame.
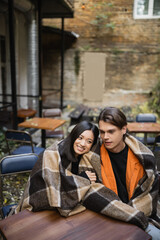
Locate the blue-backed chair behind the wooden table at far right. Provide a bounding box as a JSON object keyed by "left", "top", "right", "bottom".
{"left": 136, "top": 113, "right": 157, "bottom": 145}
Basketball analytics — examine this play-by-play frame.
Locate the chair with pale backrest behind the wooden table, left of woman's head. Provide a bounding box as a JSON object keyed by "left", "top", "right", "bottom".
{"left": 43, "top": 108, "right": 64, "bottom": 139}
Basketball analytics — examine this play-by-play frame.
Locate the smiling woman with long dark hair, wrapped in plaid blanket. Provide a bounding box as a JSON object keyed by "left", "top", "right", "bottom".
{"left": 15, "top": 121, "right": 99, "bottom": 216}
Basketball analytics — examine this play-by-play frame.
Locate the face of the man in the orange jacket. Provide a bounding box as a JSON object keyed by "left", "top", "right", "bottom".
{"left": 99, "top": 120, "right": 127, "bottom": 153}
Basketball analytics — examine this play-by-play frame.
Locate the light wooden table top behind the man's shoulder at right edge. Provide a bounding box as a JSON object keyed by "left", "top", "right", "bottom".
{"left": 127, "top": 122, "right": 160, "bottom": 133}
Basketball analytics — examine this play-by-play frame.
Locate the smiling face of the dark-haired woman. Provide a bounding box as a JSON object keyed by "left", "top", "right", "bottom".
{"left": 73, "top": 130, "right": 94, "bottom": 155}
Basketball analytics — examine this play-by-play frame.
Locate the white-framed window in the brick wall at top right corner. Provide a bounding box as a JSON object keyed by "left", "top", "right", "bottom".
{"left": 134, "top": 0, "right": 160, "bottom": 19}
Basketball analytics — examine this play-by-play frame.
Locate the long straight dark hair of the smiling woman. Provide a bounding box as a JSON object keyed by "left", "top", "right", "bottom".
{"left": 59, "top": 121, "right": 99, "bottom": 162}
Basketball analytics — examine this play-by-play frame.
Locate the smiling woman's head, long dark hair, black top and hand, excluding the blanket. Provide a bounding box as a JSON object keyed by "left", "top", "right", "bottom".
{"left": 59, "top": 121, "right": 99, "bottom": 181}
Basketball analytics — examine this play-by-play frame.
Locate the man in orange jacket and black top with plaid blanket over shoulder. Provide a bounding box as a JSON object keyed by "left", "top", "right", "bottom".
{"left": 99, "top": 107, "right": 160, "bottom": 239}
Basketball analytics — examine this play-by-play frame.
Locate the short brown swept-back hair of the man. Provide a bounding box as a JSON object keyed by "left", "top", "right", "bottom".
{"left": 98, "top": 107, "right": 127, "bottom": 129}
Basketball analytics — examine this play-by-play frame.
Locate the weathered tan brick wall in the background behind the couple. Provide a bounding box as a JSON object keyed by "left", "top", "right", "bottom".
{"left": 44, "top": 0, "right": 160, "bottom": 105}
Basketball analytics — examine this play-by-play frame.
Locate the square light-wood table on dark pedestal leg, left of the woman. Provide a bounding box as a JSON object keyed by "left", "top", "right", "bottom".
{"left": 18, "top": 117, "right": 66, "bottom": 148}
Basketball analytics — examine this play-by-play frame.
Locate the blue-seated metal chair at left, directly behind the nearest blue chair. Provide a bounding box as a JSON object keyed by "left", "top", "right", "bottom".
{"left": 5, "top": 129, "right": 45, "bottom": 155}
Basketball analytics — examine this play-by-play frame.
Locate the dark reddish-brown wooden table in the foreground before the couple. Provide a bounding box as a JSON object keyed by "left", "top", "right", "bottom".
{"left": 0, "top": 210, "right": 151, "bottom": 240}
